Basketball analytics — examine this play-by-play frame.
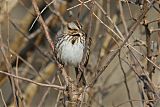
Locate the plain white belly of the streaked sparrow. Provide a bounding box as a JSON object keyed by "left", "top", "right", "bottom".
{"left": 58, "top": 42, "right": 84, "bottom": 66}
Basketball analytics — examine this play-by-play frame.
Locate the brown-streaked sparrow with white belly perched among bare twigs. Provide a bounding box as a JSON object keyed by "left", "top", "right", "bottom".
{"left": 55, "top": 21, "right": 90, "bottom": 85}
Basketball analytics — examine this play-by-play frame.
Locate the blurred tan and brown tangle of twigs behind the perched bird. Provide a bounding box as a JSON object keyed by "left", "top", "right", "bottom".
{"left": 0, "top": 0, "right": 160, "bottom": 107}
